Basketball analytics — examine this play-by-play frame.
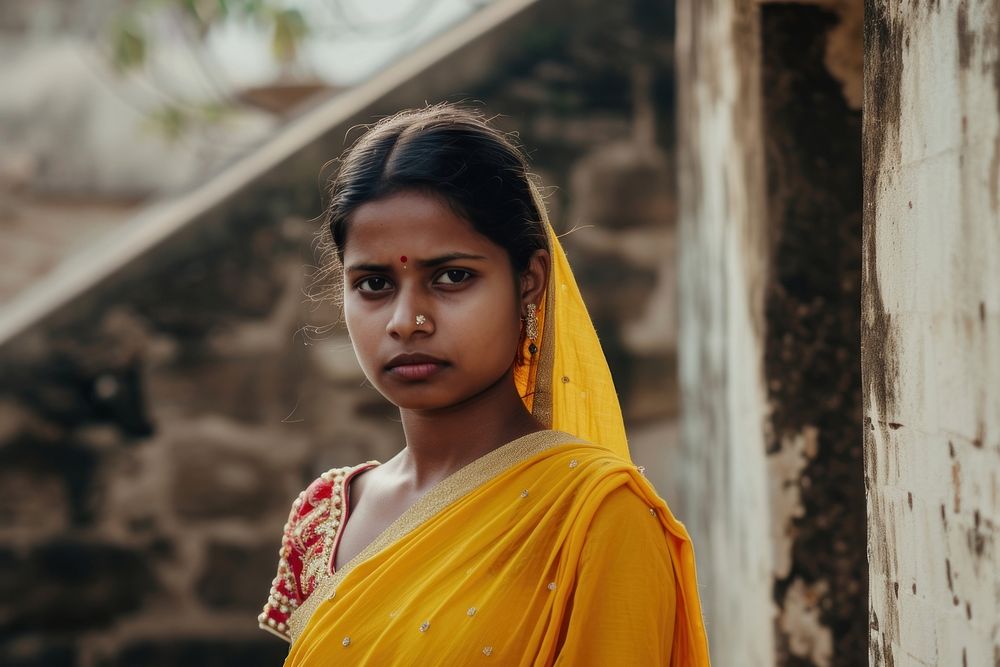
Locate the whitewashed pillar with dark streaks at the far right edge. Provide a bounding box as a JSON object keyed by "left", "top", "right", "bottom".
{"left": 862, "top": 0, "right": 1000, "bottom": 667}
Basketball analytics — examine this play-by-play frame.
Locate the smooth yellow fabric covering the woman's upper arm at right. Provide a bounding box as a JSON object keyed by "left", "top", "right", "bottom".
{"left": 555, "top": 486, "right": 677, "bottom": 666}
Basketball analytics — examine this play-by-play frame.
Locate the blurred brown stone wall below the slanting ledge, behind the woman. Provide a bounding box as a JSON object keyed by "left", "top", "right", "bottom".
{"left": 0, "top": 0, "right": 683, "bottom": 667}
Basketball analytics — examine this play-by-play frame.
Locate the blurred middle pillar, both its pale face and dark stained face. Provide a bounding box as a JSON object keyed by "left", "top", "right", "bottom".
{"left": 677, "top": 1, "right": 866, "bottom": 666}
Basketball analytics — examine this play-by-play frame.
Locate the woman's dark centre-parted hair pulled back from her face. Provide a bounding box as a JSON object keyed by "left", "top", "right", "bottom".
{"left": 323, "top": 103, "right": 546, "bottom": 274}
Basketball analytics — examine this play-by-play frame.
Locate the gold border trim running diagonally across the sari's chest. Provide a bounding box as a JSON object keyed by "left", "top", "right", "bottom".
{"left": 288, "top": 430, "right": 585, "bottom": 643}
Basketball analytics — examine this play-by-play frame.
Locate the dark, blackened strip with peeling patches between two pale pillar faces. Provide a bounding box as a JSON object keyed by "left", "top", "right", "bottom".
{"left": 760, "top": 2, "right": 868, "bottom": 667}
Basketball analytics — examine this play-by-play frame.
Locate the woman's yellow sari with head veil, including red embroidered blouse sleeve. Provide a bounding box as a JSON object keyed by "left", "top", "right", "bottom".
{"left": 259, "top": 181, "right": 709, "bottom": 667}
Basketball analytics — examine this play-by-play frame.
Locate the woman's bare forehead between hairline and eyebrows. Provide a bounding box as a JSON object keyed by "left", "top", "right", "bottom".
{"left": 344, "top": 192, "right": 504, "bottom": 261}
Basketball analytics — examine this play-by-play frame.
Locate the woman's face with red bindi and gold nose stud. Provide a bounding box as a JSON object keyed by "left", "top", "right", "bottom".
{"left": 344, "top": 192, "right": 521, "bottom": 410}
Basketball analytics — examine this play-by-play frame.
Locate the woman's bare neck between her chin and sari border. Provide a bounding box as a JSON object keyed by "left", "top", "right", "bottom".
{"left": 389, "top": 375, "right": 545, "bottom": 492}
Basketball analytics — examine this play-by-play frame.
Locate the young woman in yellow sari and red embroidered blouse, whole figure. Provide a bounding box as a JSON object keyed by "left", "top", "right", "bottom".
{"left": 259, "top": 105, "right": 709, "bottom": 666}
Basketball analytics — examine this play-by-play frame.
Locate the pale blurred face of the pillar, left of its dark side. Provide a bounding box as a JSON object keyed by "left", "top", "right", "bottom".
{"left": 676, "top": 0, "right": 775, "bottom": 666}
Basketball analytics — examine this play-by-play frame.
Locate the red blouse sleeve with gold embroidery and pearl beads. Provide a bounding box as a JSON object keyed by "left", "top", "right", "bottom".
{"left": 257, "top": 461, "right": 379, "bottom": 641}
